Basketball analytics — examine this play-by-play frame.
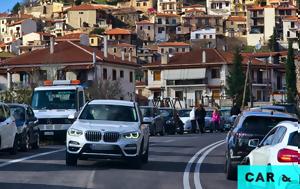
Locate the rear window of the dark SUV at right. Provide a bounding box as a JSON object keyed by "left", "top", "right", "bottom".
{"left": 242, "top": 116, "right": 295, "bottom": 135}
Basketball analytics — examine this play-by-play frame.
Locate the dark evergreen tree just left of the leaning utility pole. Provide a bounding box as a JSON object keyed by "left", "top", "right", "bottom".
{"left": 226, "top": 48, "right": 245, "bottom": 107}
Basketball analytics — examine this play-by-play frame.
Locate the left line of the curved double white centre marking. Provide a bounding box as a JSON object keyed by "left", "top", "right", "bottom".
{"left": 183, "top": 140, "right": 224, "bottom": 189}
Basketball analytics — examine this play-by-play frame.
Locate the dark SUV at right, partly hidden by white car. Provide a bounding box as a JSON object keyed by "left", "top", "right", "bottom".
{"left": 225, "top": 111, "right": 298, "bottom": 179}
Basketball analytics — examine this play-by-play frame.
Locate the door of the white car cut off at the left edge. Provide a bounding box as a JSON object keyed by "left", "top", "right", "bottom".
{"left": 2, "top": 105, "right": 17, "bottom": 148}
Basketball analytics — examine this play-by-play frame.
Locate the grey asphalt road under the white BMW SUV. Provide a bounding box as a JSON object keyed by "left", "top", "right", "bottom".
{"left": 0, "top": 133, "right": 236, "bottom": 189}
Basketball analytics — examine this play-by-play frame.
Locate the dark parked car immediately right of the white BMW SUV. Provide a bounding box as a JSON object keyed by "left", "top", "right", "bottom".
{"left": 140, "top": 106, "right": 165, "bottom": 136}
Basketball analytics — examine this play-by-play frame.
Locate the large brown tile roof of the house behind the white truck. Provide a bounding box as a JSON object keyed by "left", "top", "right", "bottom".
{"left": 3, "top": 41, "right": 138, "bottom": 67}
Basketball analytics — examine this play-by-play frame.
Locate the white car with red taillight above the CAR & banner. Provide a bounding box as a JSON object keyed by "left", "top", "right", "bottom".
{"left": 244, "top": 121, "right": 300, "bottom": 167}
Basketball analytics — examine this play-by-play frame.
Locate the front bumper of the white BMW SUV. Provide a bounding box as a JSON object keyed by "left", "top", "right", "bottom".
{"left": 67, "top": 137, "right": 142, "bottom": 159}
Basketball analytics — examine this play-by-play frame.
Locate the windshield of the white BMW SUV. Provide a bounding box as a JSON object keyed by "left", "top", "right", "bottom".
{"left": 79, "top": 104, "right": 138, "bottom": 122}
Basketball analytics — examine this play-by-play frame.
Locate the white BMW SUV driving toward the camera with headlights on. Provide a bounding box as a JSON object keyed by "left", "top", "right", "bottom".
{"left": 66, "top": 100, "right": 149, "bottom": 168}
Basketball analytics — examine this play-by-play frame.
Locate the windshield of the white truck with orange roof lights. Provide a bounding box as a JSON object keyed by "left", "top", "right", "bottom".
{"left": 32, "top": 90, "right": 76, "bottom": 110}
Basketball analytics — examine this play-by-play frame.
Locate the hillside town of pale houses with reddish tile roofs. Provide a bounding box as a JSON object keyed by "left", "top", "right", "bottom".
{"left": 0, "top": 0, "right": 300, "bottom": 107}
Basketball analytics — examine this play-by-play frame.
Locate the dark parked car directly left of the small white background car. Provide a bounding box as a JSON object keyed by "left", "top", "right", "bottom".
{"left": 159, "top": 108, "right": 184, "bottom": 134}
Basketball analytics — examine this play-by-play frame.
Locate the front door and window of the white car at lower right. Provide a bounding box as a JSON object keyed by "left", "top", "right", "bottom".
{"left": 251, "top": 127, "right": 278, "bottom": 165}
